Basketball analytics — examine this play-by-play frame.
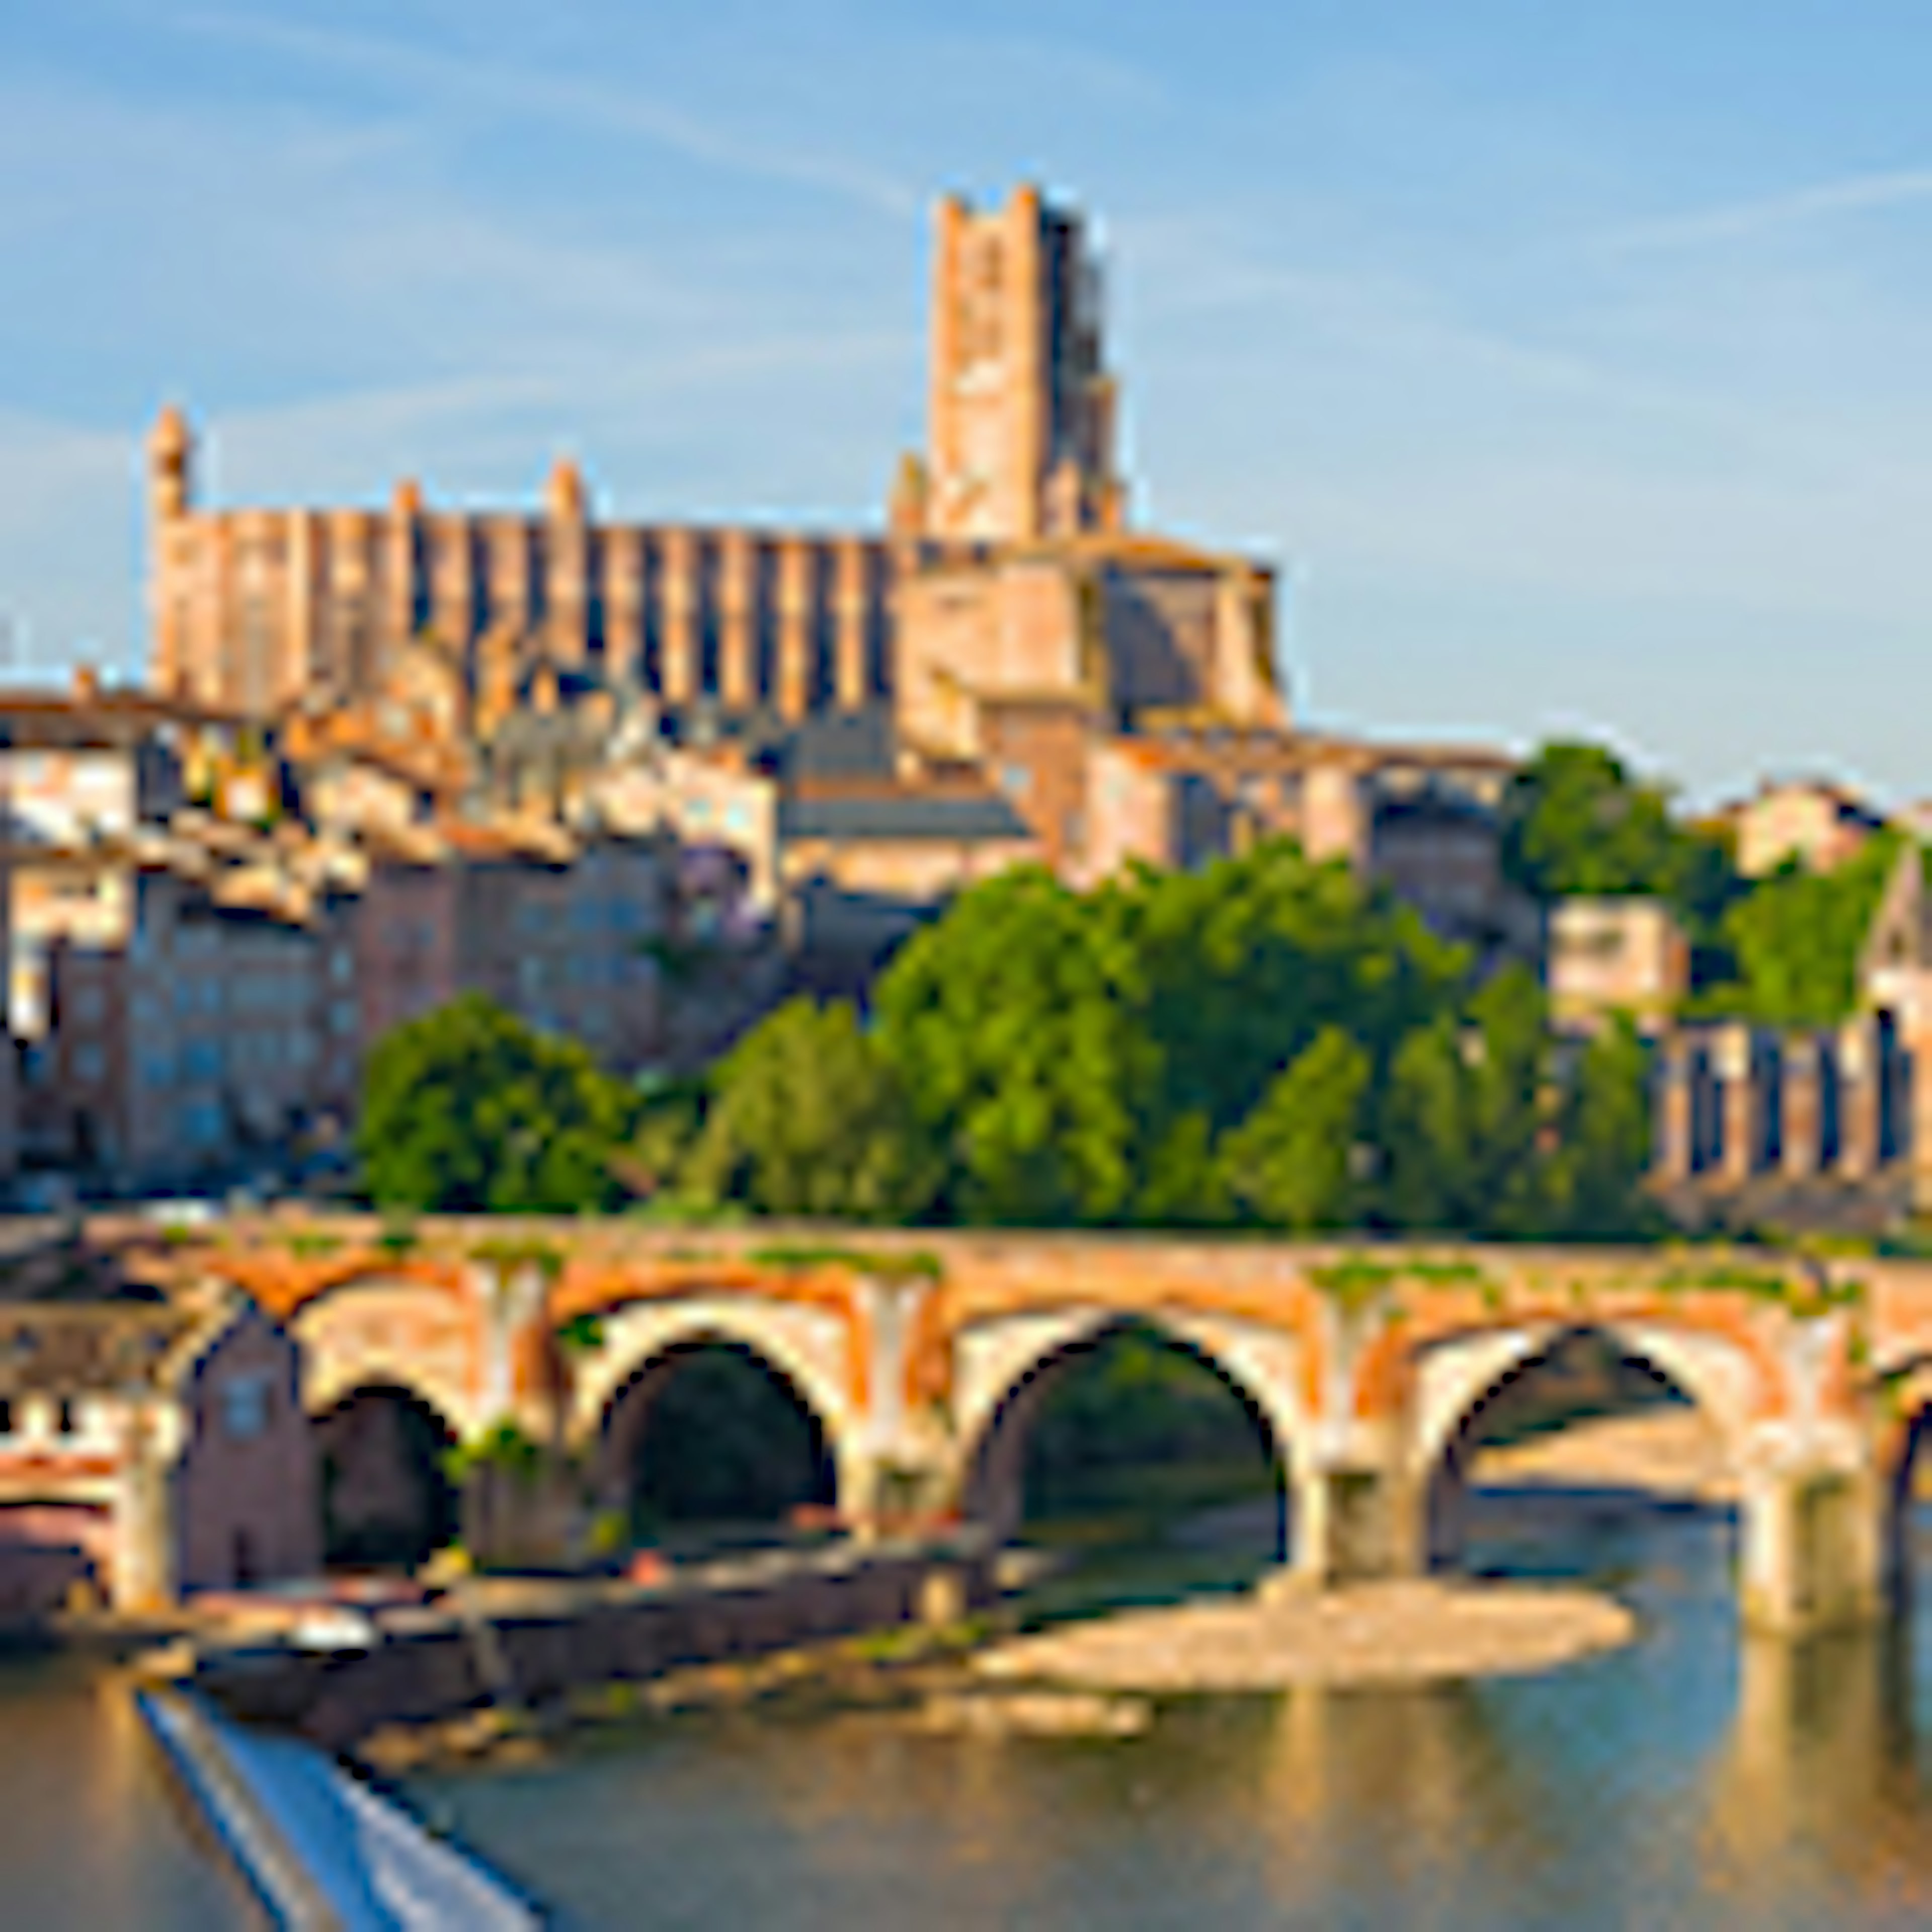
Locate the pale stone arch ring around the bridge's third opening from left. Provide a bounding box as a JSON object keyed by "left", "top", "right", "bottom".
{"left": 956, "top": 1308, "right": 1306, "bottom": 1557}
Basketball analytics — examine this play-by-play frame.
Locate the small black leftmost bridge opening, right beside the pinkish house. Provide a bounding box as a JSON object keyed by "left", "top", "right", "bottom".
{"left": 315, "top": 1383, "right": 460, "bottom": 1571}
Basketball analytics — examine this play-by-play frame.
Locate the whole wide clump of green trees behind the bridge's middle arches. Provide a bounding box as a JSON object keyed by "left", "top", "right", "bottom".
{"left": 678, "top": 844, "right": 1646, "bottom": 1233}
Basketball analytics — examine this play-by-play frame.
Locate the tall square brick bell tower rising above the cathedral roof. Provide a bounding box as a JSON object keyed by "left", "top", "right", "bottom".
{"left": 902, "top": 186, "right": 1122, "bottom": 543}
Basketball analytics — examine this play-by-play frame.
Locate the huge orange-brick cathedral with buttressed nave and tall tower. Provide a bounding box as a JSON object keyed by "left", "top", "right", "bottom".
{"left": 149, "top": 187, "right": 1507, "bottom": 925}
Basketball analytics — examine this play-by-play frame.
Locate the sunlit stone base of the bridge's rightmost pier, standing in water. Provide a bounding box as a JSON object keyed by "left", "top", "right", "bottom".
{"left": 1739, "top": 1461, "right": 1884, "bottom": 1636}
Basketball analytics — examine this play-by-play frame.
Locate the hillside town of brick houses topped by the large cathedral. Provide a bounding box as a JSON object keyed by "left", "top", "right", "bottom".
{"left": 0, "top": 187, "right": 1932, "bottom": 1217}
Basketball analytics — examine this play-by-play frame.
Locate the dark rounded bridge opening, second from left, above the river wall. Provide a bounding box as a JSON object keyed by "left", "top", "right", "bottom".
{"left": 601, "top": 1337, "right": 839, "bottom": 1544}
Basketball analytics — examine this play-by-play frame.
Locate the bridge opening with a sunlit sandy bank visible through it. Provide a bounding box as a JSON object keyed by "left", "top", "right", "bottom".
{"left": 1424, "top": 1325, "right": 1718, "bottom": 1575}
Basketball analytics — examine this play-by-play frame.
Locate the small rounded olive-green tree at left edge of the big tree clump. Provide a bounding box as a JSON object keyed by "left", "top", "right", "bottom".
{"left": 680, "top": 999, "right": 939, "bottom": 1221}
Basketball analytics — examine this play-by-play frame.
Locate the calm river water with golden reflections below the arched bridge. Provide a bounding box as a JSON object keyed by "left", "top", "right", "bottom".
{"left": 19, "top": 1499, "right": 1932, "bottom": 1932}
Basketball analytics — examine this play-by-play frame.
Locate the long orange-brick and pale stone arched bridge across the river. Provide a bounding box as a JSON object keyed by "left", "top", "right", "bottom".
{"left": 136, "top": 1219, "right": 1932, "bottom": 1631}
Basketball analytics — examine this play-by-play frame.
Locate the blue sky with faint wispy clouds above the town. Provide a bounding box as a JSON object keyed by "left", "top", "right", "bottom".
{"left": 0, "top": 0, "right": 1932, "bottom": 798}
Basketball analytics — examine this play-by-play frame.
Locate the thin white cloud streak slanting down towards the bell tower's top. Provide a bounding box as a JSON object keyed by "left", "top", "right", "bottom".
{"left": 174, "top": 12, "right": 922, "bottom": 218}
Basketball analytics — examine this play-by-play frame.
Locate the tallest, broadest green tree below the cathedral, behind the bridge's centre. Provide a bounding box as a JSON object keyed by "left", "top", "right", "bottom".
{"left": 877, "top": 840, "right": 1468, "bottom": 1225}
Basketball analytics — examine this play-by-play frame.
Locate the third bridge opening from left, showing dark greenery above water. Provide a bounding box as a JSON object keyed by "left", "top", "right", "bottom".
{"left": 960, "top": 1320, "right": 1289, "bottom": 1596}
